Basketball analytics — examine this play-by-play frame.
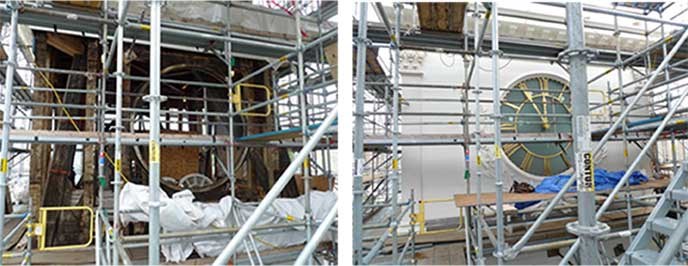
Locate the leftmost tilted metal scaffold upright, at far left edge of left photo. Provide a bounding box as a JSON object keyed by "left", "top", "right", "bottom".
{"left": 0, "top": 1, "right": 19, "bottom": 265}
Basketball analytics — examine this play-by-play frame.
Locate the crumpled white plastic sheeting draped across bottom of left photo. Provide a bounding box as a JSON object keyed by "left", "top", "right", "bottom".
{"left": 120, "top": 183, "right": 337, "bottom": 262}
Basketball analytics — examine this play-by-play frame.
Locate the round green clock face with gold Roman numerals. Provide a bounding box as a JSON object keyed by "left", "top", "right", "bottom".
{"left": 500, "top": 74, "right": 573, "bottom": 176}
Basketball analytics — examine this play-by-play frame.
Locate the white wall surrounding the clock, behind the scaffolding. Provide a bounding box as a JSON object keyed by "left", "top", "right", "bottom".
{"left": 401, "top": 51, "right": 649, "bottom": 219}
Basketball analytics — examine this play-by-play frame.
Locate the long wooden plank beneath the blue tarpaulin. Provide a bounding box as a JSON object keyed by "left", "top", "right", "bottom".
{"left": 454, "top": 179, "right": 669, "bottom": 208}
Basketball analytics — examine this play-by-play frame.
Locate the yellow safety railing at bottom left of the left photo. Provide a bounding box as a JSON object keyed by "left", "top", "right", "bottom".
{"left": 34, "top": 206, "right": 94, "bottom": 251}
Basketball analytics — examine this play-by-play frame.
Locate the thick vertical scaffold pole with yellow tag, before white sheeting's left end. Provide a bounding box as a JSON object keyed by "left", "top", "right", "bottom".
{"left": 146, "top": 0, "right": 162, "bottom": 265}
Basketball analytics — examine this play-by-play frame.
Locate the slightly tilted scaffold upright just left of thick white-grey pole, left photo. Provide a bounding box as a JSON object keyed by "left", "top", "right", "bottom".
{"left": 111, "top": 0, "right": 127, "bottom": 266}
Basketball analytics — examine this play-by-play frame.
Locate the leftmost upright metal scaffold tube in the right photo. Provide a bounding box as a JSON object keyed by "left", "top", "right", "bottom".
{"left": 352, "top": 2, "right": 368, "bottom": 264}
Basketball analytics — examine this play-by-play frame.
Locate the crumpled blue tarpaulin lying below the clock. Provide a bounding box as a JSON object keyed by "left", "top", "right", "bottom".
{"left": 515, "top": 169, "right": 648, "bottom": 210}
